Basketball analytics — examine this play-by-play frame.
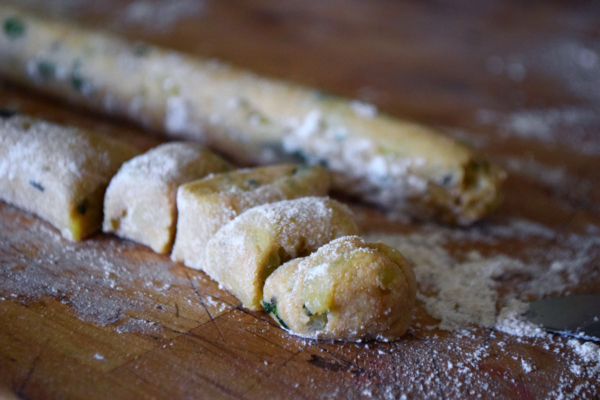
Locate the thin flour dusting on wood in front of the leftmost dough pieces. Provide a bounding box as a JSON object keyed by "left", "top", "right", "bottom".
{"left": 0, "top": 203, "right": 212, "bottom": 325}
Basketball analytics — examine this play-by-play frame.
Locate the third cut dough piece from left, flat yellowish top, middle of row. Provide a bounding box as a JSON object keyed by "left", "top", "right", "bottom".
{"left": 171, "top": 164, "right": 331, "bottom": 269}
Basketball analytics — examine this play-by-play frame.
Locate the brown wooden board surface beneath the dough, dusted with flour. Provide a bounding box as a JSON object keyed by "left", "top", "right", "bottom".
{"left": 0, "top": 0, "right": 600, "bottom": 399}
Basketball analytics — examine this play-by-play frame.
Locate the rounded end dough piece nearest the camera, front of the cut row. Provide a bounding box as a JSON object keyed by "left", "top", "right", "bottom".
{"left": 263, "top": 236, "right": 417, "bottom": 341}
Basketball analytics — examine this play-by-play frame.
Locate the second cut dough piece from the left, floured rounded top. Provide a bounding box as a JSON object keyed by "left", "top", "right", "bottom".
{"left": 103, "top": 142, "right": 231, "bottom": 254}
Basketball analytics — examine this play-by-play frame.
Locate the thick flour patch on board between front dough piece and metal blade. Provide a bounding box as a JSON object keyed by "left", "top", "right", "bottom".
{"left": 367, "top": 219, "right": 600, "bottom": 337}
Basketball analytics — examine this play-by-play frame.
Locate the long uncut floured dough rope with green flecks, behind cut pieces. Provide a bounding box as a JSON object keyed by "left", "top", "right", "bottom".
{"left": 0, "top": 6, "right": 504, "bottom": 224}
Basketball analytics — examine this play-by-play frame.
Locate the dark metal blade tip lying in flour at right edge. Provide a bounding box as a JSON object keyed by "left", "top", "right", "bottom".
{"left": 524, "top": 293, "right": 600, "bottom": 341}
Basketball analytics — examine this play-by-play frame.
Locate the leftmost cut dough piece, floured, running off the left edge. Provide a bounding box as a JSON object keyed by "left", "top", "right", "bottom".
{"left": 0, "top": 116, "right": 138, "bottom": 241}
